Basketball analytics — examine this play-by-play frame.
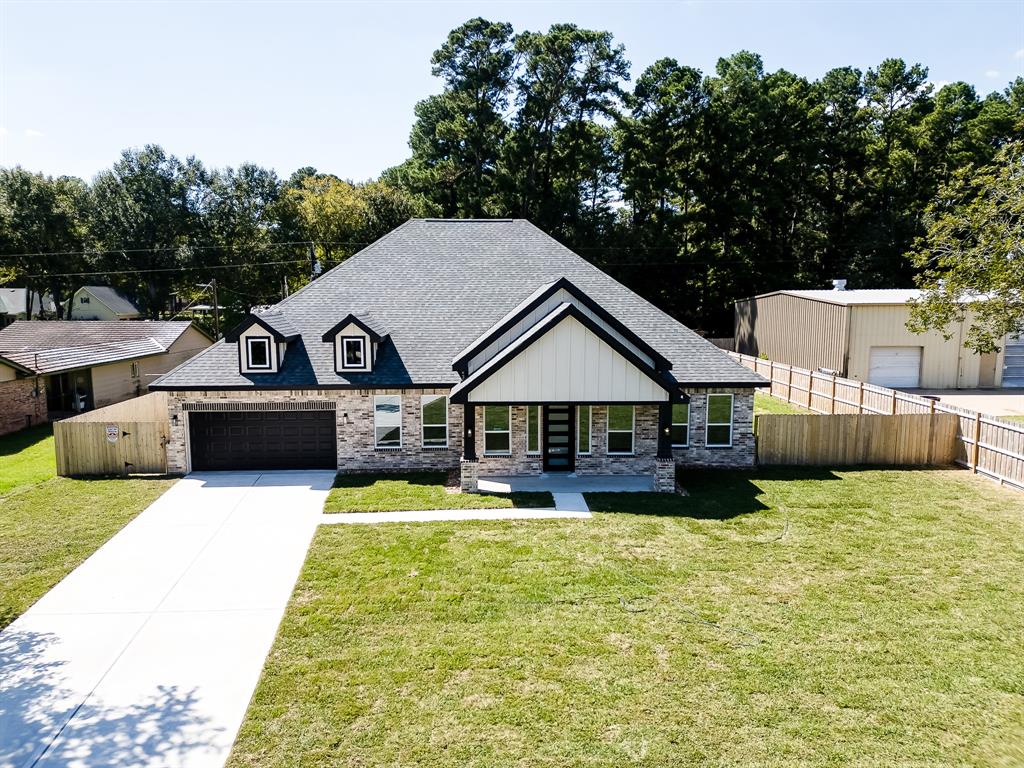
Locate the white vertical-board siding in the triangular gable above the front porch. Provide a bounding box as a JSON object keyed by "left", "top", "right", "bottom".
{"left": 469, "top": 317, "right": 669, "bottom": 402}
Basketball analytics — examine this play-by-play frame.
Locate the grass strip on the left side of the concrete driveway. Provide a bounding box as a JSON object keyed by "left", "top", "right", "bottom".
{"left": 0, "top": 427, "right": 173, "bottom": 629}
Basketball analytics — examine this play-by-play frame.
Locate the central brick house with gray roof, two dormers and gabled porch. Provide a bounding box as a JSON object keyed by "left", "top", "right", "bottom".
{"left": 151, "top": 219, "right": 766, "bottom": 490}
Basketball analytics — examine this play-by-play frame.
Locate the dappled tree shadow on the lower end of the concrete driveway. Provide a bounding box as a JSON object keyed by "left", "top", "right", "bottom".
{"left": 0, "top": 629, "right": 223, "bottom": 766}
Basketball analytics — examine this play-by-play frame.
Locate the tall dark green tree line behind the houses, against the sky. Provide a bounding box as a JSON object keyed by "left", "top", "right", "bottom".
{"left": 0, "top": 18, "right": 1024, "bottom": 335}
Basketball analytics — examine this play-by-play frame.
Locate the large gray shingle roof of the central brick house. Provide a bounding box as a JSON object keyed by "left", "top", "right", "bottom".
{"left": 151, "top": 219, "right": 764, "bottom": 389}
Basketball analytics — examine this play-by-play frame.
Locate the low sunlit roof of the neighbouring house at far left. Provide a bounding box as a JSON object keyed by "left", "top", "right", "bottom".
{"left": 0, "top": 321, "right": 191, "bottom": 374}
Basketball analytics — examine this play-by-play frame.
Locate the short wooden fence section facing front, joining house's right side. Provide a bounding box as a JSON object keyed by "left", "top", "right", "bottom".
{"left": 757, "top": 414, "right": 956, "bottom": 467}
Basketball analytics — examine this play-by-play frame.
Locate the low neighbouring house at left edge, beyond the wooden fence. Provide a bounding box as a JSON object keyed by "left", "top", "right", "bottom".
{"left": 0, "top": 321, "right": 213, "bottom": 434}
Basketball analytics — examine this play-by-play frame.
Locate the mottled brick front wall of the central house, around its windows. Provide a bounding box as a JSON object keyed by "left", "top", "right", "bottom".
{"left": 163, "top": 389, "right": 755, "bottom": 484}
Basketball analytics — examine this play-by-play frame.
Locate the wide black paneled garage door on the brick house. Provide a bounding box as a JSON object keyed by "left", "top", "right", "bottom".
{"left": 188, "top": 411, "right": 338, "bottom": 470}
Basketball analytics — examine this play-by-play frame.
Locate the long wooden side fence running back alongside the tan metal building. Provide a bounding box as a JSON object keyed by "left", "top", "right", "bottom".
{"left": 730, "top": 352, "right": 1024, "bottom": 489}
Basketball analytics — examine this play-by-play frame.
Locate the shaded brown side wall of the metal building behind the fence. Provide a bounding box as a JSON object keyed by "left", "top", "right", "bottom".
{"left": 735, "top": 294, "right": 850, "bottom": 375}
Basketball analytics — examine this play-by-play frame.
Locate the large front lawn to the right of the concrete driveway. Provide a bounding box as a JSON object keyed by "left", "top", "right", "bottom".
{"left": 229, "top": 469, "right": 1024, "bottom": 768}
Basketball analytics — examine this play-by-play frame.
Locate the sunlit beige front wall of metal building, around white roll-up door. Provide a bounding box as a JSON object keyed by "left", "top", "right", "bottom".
{"left": 843, "top": 304, "right": 1002, "bottom": 389}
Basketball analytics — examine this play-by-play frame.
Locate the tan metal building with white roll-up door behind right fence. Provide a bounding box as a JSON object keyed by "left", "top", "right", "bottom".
{"left": 735, "top": 281, "right": 1024, "bottom": 389}
